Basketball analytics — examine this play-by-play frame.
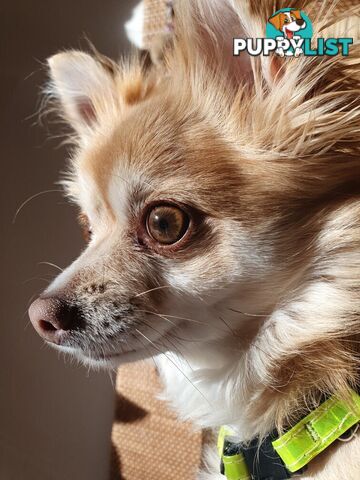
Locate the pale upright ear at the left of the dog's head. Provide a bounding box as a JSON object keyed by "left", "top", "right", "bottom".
{"left": 48, "top": 51, "right": 117, "bottom": 137}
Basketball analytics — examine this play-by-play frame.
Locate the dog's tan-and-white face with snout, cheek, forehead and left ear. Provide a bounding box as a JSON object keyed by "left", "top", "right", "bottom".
{"left": 31, "top": 53, "right": 290, "bottom": 368}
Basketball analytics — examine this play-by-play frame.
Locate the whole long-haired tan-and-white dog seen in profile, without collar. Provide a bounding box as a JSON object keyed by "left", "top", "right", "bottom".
{"left": 29, "top": 0, "right": 360, "bottom": 480}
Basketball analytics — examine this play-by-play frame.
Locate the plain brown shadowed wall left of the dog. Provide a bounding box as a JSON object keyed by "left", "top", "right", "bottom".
{"left": 0, "top": 0, "right": 134, "bottom": 480}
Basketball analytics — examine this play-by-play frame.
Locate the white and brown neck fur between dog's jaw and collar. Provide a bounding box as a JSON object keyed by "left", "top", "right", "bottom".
{"left": 160, "top": 304, "right": 358, "bottom": 441}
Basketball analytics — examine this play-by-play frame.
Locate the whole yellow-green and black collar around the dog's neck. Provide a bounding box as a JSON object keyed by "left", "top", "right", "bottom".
{"left": 218, "top": 391, "right": 360, "bottom": 480}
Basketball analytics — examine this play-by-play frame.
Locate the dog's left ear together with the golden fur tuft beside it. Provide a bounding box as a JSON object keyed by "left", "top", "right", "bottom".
{"left": 48, "top": 51, "right": 156, "bottom": 143}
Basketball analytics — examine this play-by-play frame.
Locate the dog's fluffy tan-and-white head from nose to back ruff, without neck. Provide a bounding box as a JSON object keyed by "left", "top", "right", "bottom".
{"left": 30, "top": 1, "right": 360, "bottom": 408}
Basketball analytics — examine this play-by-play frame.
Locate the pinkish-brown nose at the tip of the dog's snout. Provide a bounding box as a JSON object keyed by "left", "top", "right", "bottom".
{"left": 29, "top": 297, "right": 84, "bottom": 345}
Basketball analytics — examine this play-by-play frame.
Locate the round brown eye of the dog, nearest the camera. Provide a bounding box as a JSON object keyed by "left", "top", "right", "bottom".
{"left": 146, "top": 205, "right": 190, "bottom": 245}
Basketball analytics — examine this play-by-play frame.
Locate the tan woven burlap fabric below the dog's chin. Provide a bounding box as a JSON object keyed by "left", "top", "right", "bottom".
{"left": 112, "top": 362, "right": 202, "bottom": 480}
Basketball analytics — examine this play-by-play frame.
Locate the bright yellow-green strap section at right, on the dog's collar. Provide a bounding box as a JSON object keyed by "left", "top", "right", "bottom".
{"left": 272, "top": 392, "right": 360, "bottom": 472}
